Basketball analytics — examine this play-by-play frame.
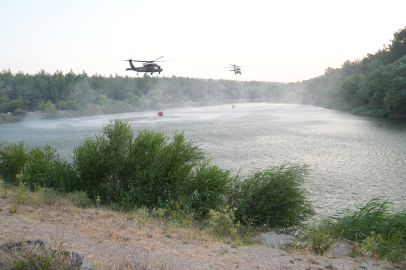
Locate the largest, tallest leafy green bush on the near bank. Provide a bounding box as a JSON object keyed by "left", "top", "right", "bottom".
{"left": 73, "top": 119, "right": 203, "bottom": 210}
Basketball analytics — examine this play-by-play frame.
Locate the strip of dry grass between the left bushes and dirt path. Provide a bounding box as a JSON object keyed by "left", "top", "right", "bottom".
{"left": 0, "top": 188, "right": 233, "bottom": 254}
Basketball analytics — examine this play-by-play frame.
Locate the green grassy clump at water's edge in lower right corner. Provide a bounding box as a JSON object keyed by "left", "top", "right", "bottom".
{"left": 303, "top": 198, "right": 406, "bottom": 262}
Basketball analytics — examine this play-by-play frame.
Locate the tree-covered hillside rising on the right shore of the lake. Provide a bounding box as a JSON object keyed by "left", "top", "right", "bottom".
{"left": 302, "top": 27, "right": 406, "bottom": 118}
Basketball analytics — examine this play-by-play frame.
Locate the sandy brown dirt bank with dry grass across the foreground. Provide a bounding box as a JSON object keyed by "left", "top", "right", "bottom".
{"left": 0, "top": 194, "right": 402, "bottom": 269}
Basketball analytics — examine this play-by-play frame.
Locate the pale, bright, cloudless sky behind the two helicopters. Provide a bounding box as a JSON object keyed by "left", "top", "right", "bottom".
{"left": 0, "top": 0, "right": 406, "bottom": 82}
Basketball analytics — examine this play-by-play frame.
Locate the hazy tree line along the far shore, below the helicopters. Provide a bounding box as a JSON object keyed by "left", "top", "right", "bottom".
{"left": 0, "top": 67, "right": 302, "bottom": 122}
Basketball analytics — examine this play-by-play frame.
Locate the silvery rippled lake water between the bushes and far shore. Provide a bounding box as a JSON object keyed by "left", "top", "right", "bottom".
{"left": 0, "top": 103, "right": 406, "bottom": 215}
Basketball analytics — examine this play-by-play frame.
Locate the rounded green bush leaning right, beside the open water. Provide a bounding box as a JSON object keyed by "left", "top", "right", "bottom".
{"left": 228, "top": 163, "right": 314, "bottom": 228}
